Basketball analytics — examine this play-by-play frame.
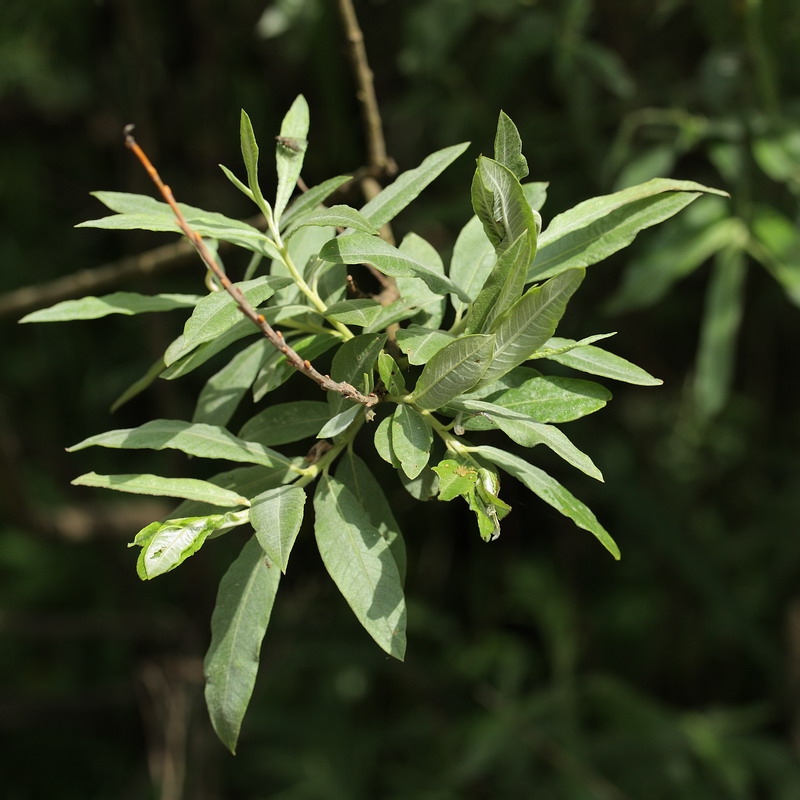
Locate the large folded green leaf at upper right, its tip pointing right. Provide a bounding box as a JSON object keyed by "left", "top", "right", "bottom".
{"left": 528, "top": 178, "right": 728, "bottom": 281}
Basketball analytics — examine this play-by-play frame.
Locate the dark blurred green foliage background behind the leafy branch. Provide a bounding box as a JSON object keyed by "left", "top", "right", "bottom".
{"left": 0, "top": 0, "right": 800, "bottom": 800}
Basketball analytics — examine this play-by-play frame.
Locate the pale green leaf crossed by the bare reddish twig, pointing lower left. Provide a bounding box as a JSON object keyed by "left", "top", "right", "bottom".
{"left": 164, "top": 276, "right": 287, "bottom": 366}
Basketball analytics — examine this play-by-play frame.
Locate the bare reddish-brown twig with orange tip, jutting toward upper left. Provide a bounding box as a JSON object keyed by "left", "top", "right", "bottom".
{"left": 125, "top": 130, "right": 378, "bottom": 407}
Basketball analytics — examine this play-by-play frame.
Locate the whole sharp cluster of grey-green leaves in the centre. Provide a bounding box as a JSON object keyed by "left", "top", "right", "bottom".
{"left": 24, "top": 96, "right": 719, "bottom": 751}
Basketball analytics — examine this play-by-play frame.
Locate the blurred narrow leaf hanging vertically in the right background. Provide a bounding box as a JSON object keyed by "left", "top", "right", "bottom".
{"left": 692, "top": 247, "right": 747, "bottom": 421}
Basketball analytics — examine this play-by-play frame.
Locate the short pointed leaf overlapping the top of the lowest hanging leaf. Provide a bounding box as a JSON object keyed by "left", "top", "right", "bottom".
{"left": 250, "top": 486, "right": 306, "bottom": 573}
